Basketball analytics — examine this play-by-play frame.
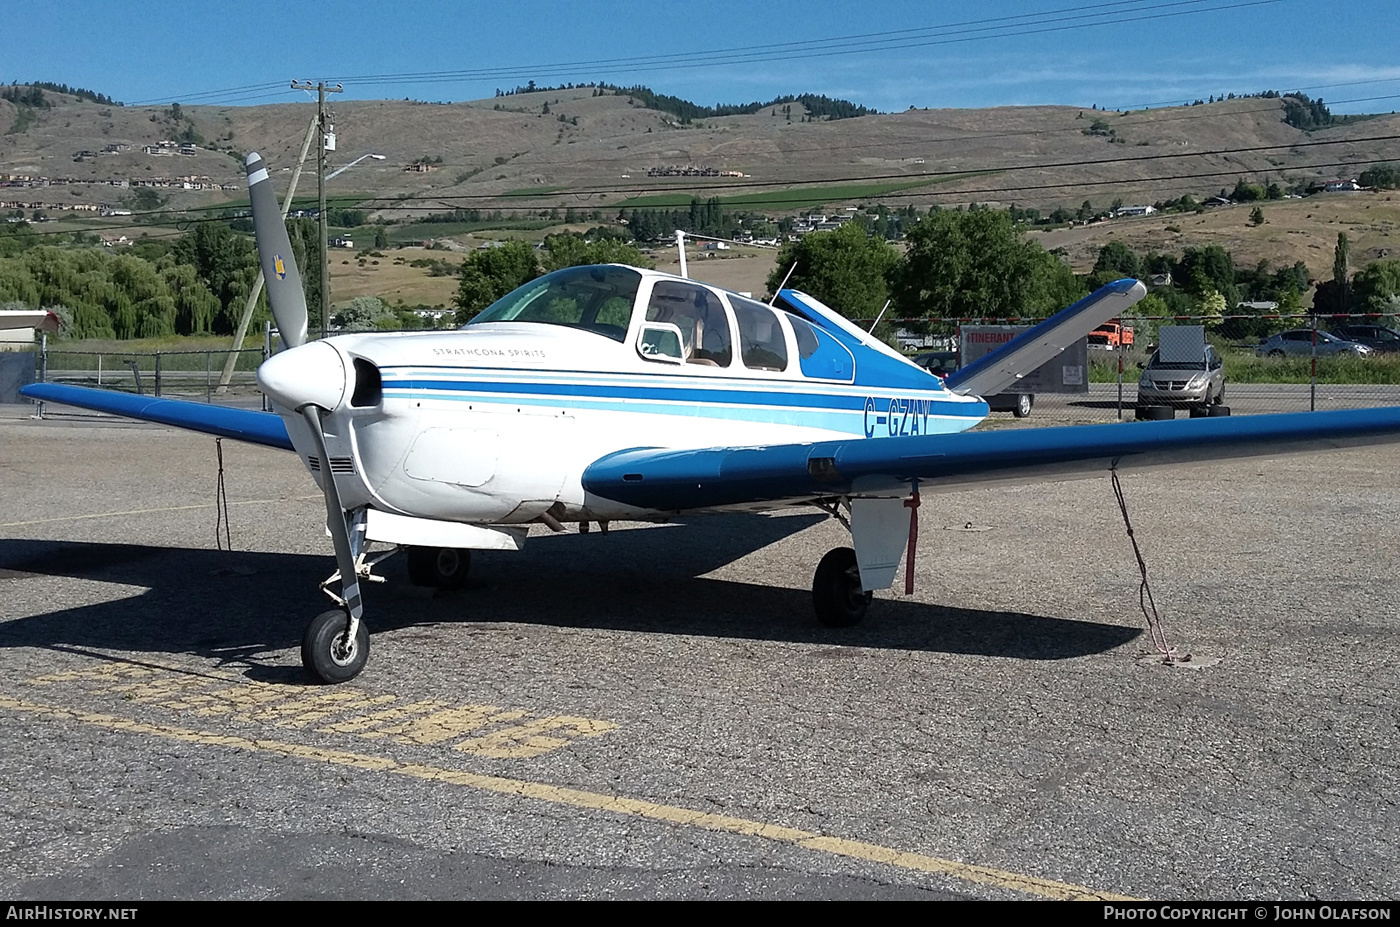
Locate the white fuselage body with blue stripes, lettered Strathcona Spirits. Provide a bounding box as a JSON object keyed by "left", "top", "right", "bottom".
{"left": 259, "top": 268, "right": 986, "bottom": 525}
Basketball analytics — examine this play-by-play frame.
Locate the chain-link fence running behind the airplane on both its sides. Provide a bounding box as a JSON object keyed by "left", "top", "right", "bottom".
{"left": 13, "top": 315, "right": 1400, "bottom": 424}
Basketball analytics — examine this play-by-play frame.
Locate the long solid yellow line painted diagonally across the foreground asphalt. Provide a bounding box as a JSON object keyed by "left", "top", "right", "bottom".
{"left": 0, "top": 696, "right": 1137, "bottom": 900}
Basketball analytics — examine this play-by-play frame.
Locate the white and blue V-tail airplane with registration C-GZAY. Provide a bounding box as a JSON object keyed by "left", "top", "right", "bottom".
{"left": 22, "top": 154, "right": 1400, "bottom": 683}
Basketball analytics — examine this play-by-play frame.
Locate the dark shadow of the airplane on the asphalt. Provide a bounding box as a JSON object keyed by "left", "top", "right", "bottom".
{"left": 0, "top": 515, "right": 1141, "bottom": 678}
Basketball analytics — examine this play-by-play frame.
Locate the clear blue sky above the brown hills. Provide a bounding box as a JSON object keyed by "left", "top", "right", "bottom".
{"left": 0, "top": 0, "right": 1400, "bottom": 112}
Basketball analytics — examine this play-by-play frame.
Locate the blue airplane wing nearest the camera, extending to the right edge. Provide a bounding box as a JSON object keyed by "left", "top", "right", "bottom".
{"left": 582, "top": 406, "right": 1400, "bottom": 511}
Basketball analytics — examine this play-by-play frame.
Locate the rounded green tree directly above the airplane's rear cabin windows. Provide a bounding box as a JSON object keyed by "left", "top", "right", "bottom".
{"left": 767, "top": 223, "right": 899, "bottom": 318}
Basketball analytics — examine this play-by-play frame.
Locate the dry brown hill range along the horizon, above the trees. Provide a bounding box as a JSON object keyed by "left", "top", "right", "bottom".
{"left": 0, "top": 88, "right": 1400, "bottom": 217}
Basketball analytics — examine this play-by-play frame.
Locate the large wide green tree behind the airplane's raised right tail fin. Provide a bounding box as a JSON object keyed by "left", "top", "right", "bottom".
{"left": 892, "top": 210, "right": 1085, "bottom": 318}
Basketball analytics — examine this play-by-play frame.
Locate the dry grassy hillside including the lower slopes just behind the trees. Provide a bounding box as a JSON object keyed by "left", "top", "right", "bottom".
{"left": 0, "top": 87, "right": 1400, "bottom": 312}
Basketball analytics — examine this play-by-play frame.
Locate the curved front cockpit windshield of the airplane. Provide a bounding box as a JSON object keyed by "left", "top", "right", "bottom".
{"left": 468, "top": 265, "right": 641, "bottom": 342}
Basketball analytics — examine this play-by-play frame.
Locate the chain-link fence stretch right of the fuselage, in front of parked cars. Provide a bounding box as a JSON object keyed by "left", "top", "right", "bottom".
{"left": 890, "top": 315, "right": 1400, "bottom": 424}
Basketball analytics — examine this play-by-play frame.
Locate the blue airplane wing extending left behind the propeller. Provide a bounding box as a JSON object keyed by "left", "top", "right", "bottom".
{"left": 20, "top": 384, "right": 293, "bottom": 451}
